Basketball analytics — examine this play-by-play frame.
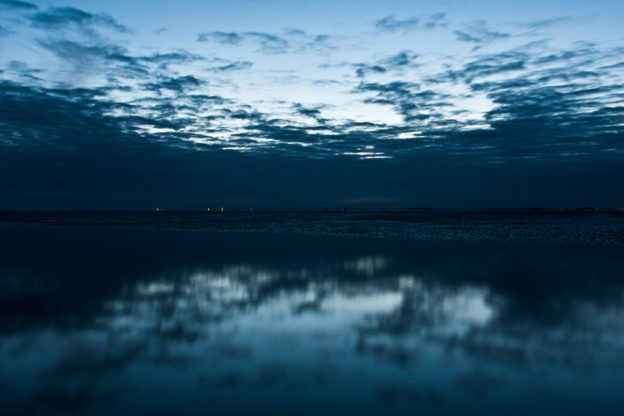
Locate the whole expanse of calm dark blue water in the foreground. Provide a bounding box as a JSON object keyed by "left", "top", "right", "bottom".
{"left": 0, "top": 225, "right": 624, "bottom": 415}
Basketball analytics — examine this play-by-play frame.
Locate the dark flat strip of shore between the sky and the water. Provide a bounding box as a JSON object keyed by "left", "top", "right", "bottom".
{"left": 0, "top": 211, "right": 624, "bottom": 245}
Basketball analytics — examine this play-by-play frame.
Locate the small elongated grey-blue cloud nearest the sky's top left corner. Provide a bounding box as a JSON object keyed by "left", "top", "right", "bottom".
{"left": 31, "top": 7, "right": 128, "bottom": 32}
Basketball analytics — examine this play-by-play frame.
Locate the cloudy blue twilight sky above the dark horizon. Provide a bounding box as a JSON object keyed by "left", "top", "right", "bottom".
{"left": 0, "top": 0, "right": 624, "bottom": 209}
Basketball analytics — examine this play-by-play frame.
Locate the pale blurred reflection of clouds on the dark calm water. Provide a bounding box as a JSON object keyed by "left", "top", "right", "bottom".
{"left": 0, "top": 244, "right": 624, "bottom": 413}
